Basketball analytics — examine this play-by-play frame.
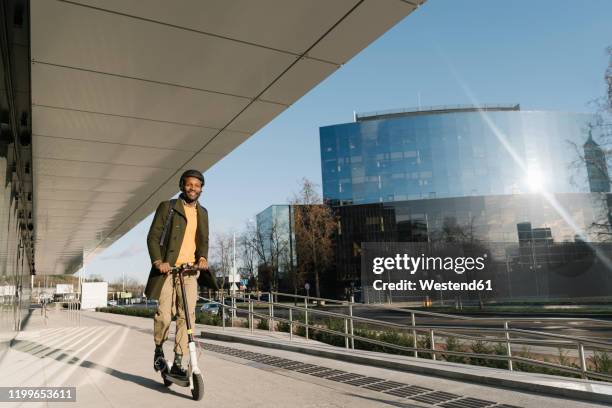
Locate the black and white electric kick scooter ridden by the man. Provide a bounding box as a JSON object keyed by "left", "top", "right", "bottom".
{"left": 160, "top": 265, "right": 204, "bottom": 401}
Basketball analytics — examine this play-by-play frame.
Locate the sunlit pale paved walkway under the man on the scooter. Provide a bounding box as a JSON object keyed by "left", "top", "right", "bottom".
{"left": 0, "top": 310, "right": 603, "bottom": 408}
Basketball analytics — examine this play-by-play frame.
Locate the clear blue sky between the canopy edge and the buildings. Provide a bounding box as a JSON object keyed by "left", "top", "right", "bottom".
{"left": 85, "top": 0, "right": 612, "bottom": 282}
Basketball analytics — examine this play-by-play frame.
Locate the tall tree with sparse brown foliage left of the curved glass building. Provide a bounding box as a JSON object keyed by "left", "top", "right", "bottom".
{"left": 292, "top": 179, "right": 337, "bottom": 297}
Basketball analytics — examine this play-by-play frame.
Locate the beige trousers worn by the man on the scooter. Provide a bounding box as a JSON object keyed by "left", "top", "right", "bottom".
{"left": 153, "top": 272, "right": 199, "bottom": 355}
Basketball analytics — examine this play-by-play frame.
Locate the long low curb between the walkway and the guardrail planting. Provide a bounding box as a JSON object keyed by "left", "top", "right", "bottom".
{"left": 200, "top": 331, "right": 612, "bottom": 404}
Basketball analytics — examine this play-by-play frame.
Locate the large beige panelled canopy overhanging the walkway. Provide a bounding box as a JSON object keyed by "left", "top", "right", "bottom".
{"left": 30, "top": 0, "right": 424, "bottom": 274}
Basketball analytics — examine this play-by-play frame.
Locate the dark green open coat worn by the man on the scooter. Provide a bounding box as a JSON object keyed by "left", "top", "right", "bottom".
{"left": 145, "top": 199, "right": 217, "bottom": 299}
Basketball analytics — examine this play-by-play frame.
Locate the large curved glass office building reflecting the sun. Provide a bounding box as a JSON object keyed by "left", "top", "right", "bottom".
{"left": 320, "top": 105, "right": 612, "bottom": 301}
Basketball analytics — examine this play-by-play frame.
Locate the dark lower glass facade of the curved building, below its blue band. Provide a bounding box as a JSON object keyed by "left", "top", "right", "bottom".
{"left": 335, "top": 193, "right": 612, "bottom": 302}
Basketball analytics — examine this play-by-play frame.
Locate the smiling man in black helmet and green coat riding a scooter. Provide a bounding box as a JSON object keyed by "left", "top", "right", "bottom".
{"left": 145, "top": 170, "right": 216, "bottom": 380}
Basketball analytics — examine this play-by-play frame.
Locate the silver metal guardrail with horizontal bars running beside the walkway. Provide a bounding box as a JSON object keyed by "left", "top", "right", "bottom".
{"left": 200, "top": 291, "right": 612, "bottom": 381}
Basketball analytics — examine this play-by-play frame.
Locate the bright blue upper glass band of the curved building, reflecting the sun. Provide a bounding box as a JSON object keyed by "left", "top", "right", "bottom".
{"left": 320, "top": 110, "right": 597, "bottom": 204}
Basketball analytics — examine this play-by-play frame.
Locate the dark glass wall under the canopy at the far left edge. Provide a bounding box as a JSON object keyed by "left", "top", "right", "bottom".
{"left": 0, "top": 0, "right": 34, "bottom": 348}
